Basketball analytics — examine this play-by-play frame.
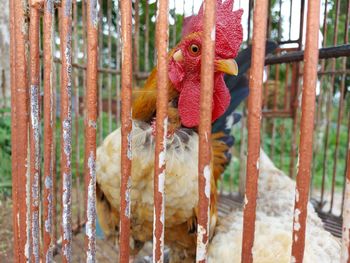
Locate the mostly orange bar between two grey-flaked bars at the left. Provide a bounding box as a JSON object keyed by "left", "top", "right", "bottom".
{"left": 43, "top": 0, "right": 56, "bottom": 262}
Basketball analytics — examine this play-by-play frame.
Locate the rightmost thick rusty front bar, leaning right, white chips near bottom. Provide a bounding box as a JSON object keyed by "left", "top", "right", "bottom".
{"left": 291, "top": 0, "right": 320, "bottom": 263}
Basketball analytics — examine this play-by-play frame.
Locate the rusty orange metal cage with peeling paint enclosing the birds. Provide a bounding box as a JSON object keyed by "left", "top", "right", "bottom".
{"left": 1, "top": 0, "right": 350, "bottom": 263}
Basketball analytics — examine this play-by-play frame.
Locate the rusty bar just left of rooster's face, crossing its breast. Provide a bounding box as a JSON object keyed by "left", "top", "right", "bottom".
{"left": 153, "top": 0, "right": 169, "bottom": 262}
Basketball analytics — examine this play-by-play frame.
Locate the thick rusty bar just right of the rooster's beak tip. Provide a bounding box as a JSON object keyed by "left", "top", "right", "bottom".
{"left": 241, "top": 0, "right": 268, "bottom": 263}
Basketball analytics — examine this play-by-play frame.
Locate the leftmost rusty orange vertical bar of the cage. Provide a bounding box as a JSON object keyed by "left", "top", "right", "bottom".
{"left": 9, "top": 0, "right": 20, "bottom": 262}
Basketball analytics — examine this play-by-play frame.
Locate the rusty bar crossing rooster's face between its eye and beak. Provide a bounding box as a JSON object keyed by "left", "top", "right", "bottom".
{"left": 196, "top": 0, "right": 216, "bottom": 262}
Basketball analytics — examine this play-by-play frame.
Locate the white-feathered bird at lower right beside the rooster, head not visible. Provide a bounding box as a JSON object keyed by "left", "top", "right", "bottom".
{"left": 208, "top": 149, "right": 341, "bottom": 263}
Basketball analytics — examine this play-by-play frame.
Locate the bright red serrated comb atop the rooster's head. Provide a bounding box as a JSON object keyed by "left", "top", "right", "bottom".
{"left": 182, "top": 0, "right": 243, "bottom": 58}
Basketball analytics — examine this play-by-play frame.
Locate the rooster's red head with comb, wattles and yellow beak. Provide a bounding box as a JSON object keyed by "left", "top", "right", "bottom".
{"left": 169, "top": 0, "right": 243, "bottom": 127}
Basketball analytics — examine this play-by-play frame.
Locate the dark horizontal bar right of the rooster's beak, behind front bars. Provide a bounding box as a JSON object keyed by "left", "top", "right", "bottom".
{"left": 265, "top": 44, "right": 350, "bottom": 65}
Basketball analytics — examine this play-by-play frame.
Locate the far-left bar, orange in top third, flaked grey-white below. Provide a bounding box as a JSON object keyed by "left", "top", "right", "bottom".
{"left": 29, "top": 1, "right": 41, "bottom": 262}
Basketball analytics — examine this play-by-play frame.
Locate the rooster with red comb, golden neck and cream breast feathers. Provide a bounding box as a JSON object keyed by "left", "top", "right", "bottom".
{"left": 96, "top": 0, "right": 243, "bottom": 262}
